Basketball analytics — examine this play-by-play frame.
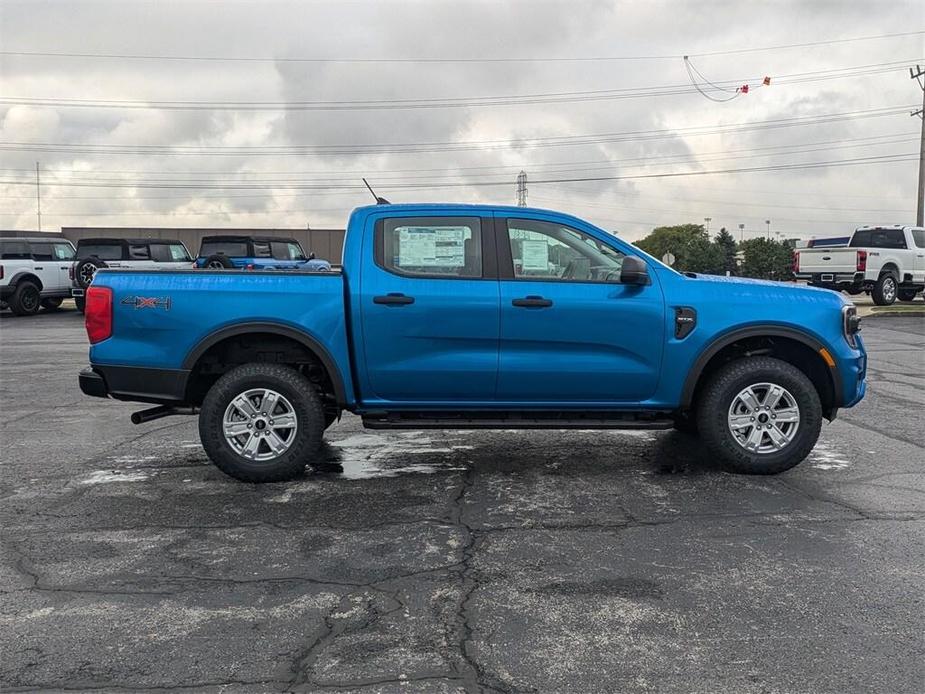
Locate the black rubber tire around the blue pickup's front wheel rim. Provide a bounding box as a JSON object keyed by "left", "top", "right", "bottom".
{"left": 697, "top": 357, "right": 822, "bottom": 475}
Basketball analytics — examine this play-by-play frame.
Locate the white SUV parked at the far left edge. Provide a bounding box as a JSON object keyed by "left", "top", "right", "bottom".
{"left": 0, "top": 237, "right": 74, "bottom": 316}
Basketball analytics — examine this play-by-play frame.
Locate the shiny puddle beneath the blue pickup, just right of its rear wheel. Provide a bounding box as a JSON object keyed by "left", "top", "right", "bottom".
{"left": 315, "top": 431, "right": 474, "bottom": 480}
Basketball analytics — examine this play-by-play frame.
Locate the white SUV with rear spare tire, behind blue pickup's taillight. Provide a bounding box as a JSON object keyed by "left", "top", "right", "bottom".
{"left": 71, "top": 238, "right": 193, "bottom": 311}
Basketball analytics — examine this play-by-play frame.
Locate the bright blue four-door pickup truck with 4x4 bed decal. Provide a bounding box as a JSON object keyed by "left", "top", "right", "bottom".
{"left": 80, "top": 204, "right": 867, "bottom": 482}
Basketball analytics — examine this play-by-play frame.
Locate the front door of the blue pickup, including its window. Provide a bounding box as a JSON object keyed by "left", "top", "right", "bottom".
{"left": 497, "top": 218, "right": 665, "bottom": 406}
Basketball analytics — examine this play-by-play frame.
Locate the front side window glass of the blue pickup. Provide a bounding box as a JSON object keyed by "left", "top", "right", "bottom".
{"left": 507, "top": 219, "right": 624, "bottom": 283}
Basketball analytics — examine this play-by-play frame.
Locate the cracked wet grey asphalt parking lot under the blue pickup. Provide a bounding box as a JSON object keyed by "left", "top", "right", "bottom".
{"left": 0, "top": 311, "right": 925, "bottom": 693}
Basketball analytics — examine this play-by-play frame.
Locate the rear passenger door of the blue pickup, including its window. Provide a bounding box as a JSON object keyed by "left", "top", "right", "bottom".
{"left": 353, "top": 212, "right": 499, "bottom": 406}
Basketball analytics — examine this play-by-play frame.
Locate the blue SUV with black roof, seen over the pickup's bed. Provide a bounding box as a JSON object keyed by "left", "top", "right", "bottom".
{"left": 196, "top": 236, "right": 331, "bottom": 270}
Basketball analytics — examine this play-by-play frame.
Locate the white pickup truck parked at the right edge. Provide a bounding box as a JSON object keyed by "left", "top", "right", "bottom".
{"left": 793, "top": 225, "right": 925, "bottom": 306}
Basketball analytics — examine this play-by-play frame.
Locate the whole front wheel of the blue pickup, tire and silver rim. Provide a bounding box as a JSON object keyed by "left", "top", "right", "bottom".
{"left": 697, "top": 357, "right": 822, "bottom": 475}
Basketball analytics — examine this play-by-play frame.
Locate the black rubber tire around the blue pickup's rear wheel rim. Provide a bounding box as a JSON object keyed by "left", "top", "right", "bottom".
{"left": 199, "top": 363, "right": 325, "bottom": 482}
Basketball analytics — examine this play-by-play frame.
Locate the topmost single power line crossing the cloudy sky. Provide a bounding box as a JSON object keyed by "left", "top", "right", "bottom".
{"left": 0, "top": 30, "right": 925, "bottom": 64}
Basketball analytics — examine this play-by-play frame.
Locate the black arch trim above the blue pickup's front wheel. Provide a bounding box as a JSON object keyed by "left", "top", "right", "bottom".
{"left": 681, "top": 325, "right": 842, "bottom": 419}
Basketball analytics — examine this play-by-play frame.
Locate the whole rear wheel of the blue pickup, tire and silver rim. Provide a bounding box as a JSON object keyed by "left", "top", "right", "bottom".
{"left": 199, "top": 363, "right": 325, "bottom": 482}
